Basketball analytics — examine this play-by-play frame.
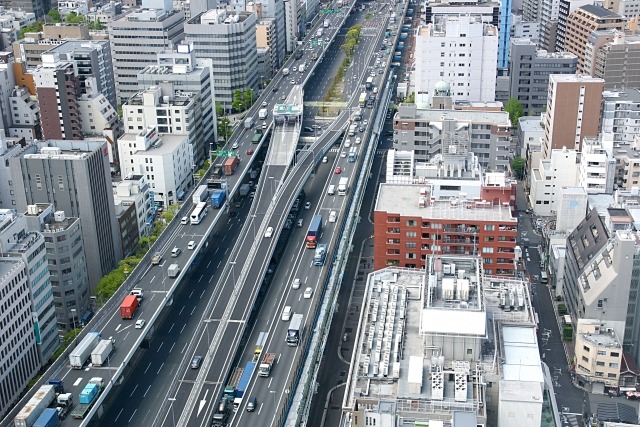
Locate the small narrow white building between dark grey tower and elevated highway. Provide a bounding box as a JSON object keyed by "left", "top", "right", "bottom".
{"left": 113, "top": 175, "right": 153, "bottom": 238}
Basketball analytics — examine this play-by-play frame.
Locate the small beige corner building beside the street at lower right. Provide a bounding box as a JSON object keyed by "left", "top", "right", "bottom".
{"left": 575, "top": 319, "right": 622, "bottom": 393}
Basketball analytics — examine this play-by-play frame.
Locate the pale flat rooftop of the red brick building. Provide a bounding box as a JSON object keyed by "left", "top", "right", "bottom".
{"left": 375, "top": 183, "right": 517, "bottom": 224}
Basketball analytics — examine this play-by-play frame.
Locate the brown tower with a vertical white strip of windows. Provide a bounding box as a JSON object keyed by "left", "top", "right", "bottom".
{"left": 542, "top": 74, "right": 604, "bottom": 158}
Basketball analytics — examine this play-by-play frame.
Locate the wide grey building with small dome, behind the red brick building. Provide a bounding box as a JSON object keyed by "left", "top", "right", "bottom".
{"left": 393, "top": 102, "right": 511, "bottom": 172}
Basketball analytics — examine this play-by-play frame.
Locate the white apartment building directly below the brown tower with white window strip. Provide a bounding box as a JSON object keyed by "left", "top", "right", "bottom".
{"left": 529, "top": 148, "right": 580, "bottom": 216}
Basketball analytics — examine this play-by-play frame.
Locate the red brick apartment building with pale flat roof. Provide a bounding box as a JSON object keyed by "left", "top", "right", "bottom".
{"left": 373, "top": 184, "right": 517, "bottom": 276}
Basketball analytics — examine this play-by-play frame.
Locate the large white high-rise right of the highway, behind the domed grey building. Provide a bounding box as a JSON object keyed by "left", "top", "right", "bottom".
{"left": 412, "top": 15, "right": 498, "bottom": 107}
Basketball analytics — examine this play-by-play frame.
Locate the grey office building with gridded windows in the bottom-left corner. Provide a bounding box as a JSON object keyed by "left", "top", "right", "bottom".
{"left": 0, "top": 256, "right": 37, "bottom": 417}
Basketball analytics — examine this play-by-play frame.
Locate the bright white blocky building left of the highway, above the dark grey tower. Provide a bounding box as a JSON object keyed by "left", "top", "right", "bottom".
{"left": 118, "top": 125, "right": 195, "bottom": 207}
